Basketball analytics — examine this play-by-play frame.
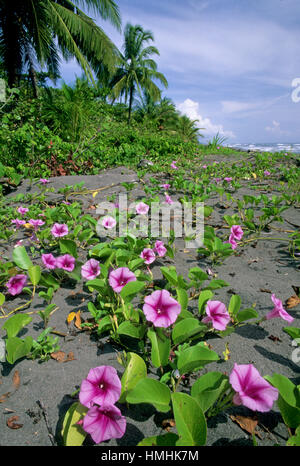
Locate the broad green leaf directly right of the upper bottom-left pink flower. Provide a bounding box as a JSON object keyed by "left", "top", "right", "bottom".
{"left": 126, "top": 377, "right": 171, "bottom": 413}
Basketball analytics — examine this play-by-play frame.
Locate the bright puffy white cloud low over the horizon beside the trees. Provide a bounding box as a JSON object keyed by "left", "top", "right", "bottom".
{"left": 176, "top": 99, "right": 235, "bottom": 138}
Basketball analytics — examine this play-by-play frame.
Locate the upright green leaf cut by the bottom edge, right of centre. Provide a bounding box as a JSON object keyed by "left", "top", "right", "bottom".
{"left": 171, "top": 393, "right": 207, "bottom": 446}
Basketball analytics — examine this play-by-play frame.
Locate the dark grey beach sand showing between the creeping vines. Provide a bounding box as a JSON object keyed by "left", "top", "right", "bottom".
{"left": 0, "top": 160, "right": 300, "bottom": 446}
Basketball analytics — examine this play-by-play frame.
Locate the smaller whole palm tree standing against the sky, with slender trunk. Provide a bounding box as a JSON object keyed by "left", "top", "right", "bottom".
{"left": 112, "top": 23, "right": 168, "bottom": 123}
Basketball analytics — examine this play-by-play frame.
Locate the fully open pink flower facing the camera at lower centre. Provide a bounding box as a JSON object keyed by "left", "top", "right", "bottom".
{"left": 143, "top": 290, "right": 181, "bottom": 328}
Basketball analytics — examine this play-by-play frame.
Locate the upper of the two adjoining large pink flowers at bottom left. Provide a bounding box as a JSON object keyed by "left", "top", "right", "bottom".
{"left": 79, "top": 366, "right": 121, "bottom": 408}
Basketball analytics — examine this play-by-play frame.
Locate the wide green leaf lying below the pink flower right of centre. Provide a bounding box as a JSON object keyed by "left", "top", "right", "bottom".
{"left": 177, "top": 345, "right": 219, "bottom": 374}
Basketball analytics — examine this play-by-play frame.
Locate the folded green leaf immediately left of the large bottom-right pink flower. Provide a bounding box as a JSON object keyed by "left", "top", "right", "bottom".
{"left": 191, "top": 372, "right": 229, "bottom": 413}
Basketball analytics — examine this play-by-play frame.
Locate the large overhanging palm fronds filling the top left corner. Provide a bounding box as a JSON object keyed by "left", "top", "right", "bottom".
{"left": 0, "top": 0, "right": 121, "bottom": 95}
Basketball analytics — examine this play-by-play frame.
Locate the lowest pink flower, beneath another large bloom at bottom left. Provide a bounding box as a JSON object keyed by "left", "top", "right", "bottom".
{"left": 82, "top": 405, "right": 126, "bottom": 443}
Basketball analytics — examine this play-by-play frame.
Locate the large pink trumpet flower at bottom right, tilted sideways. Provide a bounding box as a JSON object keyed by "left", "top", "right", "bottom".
{"left": 229, "top": 363, "right": 278, "bottom": 412}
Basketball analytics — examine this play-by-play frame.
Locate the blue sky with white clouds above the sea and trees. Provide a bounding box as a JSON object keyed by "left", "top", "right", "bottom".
{"left": 61, "top": 0, "right": 300, "bottom": 143}
